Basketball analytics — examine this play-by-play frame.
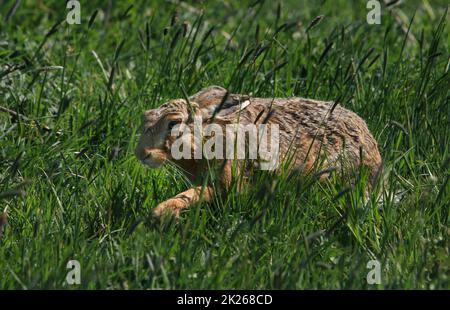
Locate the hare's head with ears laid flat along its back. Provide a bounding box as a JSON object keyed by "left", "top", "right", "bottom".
{"left": 135, "top": 86, "right": 248, "bottom": 168}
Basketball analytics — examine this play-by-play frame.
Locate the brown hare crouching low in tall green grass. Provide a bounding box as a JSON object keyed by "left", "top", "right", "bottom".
{"left": 135, "top": 86, "right": 381, "bottom": 217}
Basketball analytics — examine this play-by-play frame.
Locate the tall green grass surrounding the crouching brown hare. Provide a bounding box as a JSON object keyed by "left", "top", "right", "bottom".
{"left": 0, "top": 0, "right": 450, "bottom": 289}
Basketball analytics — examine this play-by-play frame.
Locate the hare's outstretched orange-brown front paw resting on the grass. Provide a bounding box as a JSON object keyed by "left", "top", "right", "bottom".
{"left": 153, "top": 186, "right": 213, "bottom": 218}
